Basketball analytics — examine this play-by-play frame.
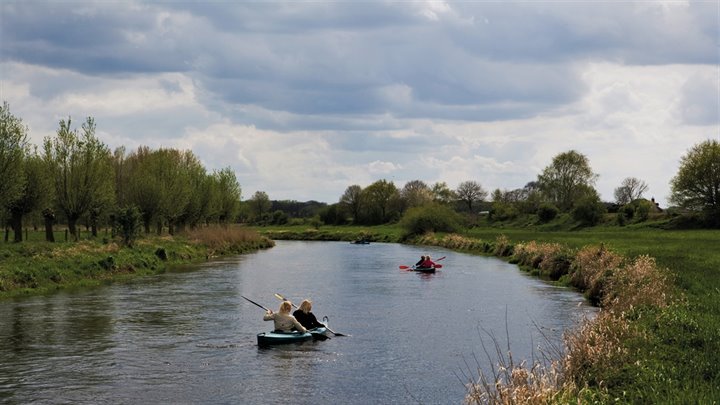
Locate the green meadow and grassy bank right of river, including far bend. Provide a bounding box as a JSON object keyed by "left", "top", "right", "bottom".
{"left": 259, "top": 223, "right": 720, "bottom": 404}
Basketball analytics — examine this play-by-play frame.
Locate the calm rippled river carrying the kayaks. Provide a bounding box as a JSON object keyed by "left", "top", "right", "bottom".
{"left": 0, "top": 241, "right": 592, "bottom": 404}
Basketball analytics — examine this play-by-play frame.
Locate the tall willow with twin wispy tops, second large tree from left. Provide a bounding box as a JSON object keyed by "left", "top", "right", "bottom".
{"left": 44, "top": 117, "right": 115, "bottom": 240}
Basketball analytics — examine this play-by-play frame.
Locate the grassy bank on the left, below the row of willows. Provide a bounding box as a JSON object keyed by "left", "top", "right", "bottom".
{"left": 0, "top": 227, "right": 274, "bottom": 299}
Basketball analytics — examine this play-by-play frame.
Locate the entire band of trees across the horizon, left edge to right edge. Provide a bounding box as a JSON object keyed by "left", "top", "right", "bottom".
{"left": 0, "top": 102, "right": 720, "bottom": 241}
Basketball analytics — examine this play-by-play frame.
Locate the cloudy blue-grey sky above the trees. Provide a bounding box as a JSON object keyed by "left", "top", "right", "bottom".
{"left": 0, "top": 0, "right": 720, "bottom": 207}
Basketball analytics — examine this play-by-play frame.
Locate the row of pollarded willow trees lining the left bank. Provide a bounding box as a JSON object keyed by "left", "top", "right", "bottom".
{"left": 0, "top": 102, "right": 241, "bottom": 242}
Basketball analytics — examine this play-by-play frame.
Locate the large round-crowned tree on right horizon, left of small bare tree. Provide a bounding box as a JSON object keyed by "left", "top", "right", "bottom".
{"left": 537, "top": 150, "right": 598, "bottom": 212}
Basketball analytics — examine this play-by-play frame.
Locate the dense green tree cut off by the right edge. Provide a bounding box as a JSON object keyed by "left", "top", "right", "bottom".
{"left": 670, "top": 139, "right": 720, "bottom": 226}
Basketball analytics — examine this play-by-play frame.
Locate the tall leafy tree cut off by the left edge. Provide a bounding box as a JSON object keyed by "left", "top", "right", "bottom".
{"left": 0, "top": 102, "right": 28, "bottom": 210}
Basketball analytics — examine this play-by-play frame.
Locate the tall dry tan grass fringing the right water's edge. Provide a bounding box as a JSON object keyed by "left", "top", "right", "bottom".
{"left": 465, "top": 243, "right": 674, "bottom": 404}
